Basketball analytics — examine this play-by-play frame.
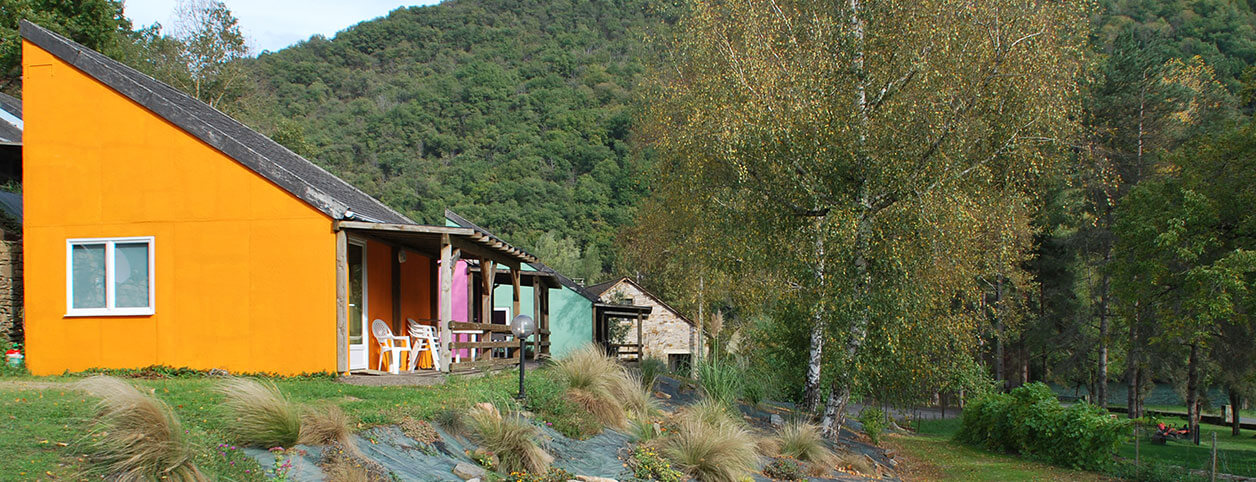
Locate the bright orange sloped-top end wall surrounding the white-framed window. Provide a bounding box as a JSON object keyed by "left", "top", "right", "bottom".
{"left": 23, "top": 41, "right": 337, "bottom": 374}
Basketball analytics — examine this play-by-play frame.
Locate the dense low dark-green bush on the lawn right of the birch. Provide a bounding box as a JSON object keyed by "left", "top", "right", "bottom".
{"left": 956, "top": 383, "right": 1129, "bottom": 471}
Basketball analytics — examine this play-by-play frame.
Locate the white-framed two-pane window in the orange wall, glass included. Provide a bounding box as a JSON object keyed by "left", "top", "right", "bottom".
{"left": 65, "top": 236, "right": 156, "bottom": 316}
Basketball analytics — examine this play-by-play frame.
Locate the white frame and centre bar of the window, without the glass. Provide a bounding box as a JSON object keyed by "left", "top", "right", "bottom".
{"left": 65, "top": 236, "right": 157, "bottom": 316}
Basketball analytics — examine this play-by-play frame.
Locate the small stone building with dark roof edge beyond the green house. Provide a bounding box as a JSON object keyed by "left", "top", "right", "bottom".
{"left": 589, "top": 277, "right": 697, "bottom": 369}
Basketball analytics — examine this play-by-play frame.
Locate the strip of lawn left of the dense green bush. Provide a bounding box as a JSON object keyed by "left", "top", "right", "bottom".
{"left": 885, "top": 419, "right": 1110, "bottom": 482}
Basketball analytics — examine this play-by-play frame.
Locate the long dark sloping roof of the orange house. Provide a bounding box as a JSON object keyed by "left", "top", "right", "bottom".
{"left": 21, "top": 20, "right": 414, "bottom": 225}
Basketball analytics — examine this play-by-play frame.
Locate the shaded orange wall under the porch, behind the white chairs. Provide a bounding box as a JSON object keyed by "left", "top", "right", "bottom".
{"left": 365, "top": 240, "right": 435, "bottom": 369}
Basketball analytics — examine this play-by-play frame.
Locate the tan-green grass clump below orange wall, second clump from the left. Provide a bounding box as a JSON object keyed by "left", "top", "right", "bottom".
{"left": 219, "top": 378, "right": 301, "bottom": 448}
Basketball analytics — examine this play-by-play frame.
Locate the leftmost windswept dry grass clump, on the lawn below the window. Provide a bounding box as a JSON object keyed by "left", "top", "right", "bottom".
{"left": 75, "top": 375, "right": 207, "bottom": 481}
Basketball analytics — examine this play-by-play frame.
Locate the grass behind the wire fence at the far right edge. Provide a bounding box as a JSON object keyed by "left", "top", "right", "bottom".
{"left": 1120, "top": 418, "right": 1256, "bottom": 477}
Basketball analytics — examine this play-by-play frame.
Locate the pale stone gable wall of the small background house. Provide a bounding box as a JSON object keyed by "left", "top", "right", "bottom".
{"left": 602, "top": 282, "right": 693, "bottom": 360}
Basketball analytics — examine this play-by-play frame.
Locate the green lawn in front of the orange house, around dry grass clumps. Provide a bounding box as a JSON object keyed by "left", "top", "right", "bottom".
{"left": 0, "top": 373, "right": 517, "bottom": 479}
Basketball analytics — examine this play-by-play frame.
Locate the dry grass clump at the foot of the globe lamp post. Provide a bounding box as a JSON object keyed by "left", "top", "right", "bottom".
{"left": 467, "top": 403, "right": 554, "bottom": 473}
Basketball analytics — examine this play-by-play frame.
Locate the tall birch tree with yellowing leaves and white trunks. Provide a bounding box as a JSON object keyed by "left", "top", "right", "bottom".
{"left": 644, "top": 0, "right": 1085, "bottom": 436}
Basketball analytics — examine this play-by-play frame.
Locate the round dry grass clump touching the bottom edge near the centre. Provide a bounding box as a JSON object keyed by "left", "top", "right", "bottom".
{"left": 663, "top": 400, "right": 759, "bottom": 482}
